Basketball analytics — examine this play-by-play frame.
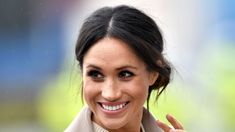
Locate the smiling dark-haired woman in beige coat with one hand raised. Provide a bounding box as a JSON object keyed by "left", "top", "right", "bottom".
{"left": 65, "top": 6, "right": 183, "bottom": 132}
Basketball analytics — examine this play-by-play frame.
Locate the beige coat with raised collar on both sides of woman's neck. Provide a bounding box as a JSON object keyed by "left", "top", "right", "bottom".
{"left": 65, "top": 107, "right": 162, "bottom": 132}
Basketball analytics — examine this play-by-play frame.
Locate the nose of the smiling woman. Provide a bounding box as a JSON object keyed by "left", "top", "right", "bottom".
{"left": 101, "top": 79, "right": 122, "bottom": 101}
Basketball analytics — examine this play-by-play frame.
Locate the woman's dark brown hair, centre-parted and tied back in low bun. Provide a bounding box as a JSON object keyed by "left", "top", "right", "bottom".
{"left": 75, "top": 5, "right": 171, "bottom": 108}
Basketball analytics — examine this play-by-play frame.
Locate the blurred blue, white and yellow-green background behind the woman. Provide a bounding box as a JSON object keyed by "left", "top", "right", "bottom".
{"left": 0, "top": 0, "right": 235, "bottom": 132}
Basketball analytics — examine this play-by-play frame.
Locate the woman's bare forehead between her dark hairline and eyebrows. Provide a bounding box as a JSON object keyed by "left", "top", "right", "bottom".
{"left": 83, "top": 37, "right": 144, "bottom": 68}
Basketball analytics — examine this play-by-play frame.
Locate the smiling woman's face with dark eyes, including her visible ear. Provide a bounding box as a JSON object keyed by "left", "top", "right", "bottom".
{"left": 82, "top": 38, "right": 157, "bottom": 130}
